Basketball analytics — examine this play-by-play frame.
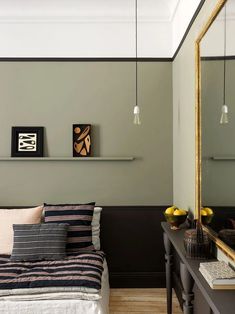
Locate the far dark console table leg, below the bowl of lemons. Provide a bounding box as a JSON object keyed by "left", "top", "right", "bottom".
{"left": 163, "top": 232, "right": 173, "bottom": 314}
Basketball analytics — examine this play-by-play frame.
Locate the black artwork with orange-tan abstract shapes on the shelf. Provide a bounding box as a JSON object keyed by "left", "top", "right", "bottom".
{"left": 73, "top": 124, "right": 91, "bottom": 157}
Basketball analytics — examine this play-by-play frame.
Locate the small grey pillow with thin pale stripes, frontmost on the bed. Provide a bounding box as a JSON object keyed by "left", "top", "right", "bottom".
{"left": 11, "top": 224, "right": 68, "bottom": 261}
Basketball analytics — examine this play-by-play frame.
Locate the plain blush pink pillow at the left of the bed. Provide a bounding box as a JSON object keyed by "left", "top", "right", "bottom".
{"left": 0, "top": 206, "right": 43, "bottom": 255}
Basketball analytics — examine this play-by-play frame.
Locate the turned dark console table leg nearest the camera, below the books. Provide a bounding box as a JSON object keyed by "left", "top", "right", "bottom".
{"left": 180, "top": 262, "right": 194, "bottom": 314}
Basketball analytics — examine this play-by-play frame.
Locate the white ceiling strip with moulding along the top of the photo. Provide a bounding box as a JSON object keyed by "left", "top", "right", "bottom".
{"left": 0, "top": 0, "right": 179, "bottom": 21}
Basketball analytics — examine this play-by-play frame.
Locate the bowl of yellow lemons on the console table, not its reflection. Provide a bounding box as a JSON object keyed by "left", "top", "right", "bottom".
{"left": 164, "top": 206, "right": 188, "bottom": 230}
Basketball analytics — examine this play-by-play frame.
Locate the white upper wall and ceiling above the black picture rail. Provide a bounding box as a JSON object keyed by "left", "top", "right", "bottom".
{"left": 0, "top": 0, "right": 200, "bottom": 57}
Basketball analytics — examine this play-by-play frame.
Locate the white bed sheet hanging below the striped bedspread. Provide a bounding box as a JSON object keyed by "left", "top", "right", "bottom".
{"left": 0, "top": 260, "right": 109, "bottom": 314}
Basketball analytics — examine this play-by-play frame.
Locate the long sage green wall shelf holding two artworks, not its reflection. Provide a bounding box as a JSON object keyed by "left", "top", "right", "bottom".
{"left": 0, "top": 157, "right": 135, "bottom": 161}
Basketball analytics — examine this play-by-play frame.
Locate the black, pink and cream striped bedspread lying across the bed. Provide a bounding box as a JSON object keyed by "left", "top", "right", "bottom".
{"left": 0, "top": 251, "right": 104, "bottom": 296}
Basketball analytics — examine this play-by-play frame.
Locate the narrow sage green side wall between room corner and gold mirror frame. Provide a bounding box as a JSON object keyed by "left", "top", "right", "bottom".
{"left": 173, "top": 0, "right": 217, "bottom": 211}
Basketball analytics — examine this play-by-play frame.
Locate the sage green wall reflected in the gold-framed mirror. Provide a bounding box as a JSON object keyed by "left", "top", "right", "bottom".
{"left": 202, "top": 60, "right": 235, "bottom": 206}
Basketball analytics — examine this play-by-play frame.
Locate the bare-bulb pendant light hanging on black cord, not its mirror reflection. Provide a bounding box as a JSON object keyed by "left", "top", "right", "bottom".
{"left": 134, "top": 0, "right": 141, "bottom": 125}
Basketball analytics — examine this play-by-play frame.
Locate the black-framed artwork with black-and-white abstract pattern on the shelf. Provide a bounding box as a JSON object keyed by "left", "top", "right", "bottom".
{"left": 11, "top": 126, "right": 43, "bottom": 157}
